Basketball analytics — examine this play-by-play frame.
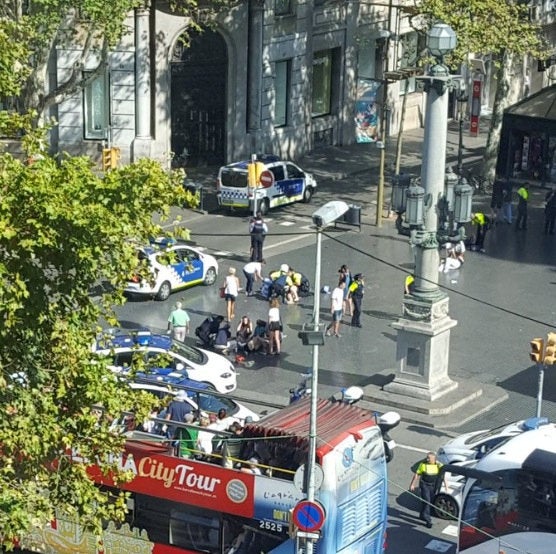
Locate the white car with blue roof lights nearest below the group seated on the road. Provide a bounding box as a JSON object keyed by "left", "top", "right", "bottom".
{"left": 93, "top": 330, "right": 237, "bottom": 393}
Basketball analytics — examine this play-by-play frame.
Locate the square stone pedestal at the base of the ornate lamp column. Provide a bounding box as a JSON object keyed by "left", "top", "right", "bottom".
{"left": 383, "top": 296, "right": 458, "bottom": 402}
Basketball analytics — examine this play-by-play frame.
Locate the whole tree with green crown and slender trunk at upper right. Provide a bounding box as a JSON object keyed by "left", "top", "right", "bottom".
{"left": 419, "top": 0, "right": 546, "bottom": 180}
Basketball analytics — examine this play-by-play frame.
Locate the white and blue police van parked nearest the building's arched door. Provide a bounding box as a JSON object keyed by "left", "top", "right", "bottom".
{"left": 216, "top": 154, "right": 317, "bottom": 215}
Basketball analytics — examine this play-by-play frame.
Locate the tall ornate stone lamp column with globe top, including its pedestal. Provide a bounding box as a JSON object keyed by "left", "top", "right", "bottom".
{"left": 384, "top": 23, "right": 462, "bottom": 402}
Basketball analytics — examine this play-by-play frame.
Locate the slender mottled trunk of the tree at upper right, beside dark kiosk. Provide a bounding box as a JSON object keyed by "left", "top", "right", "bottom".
{"left": 483, "top": 50, "right": 515, "bottom": 182}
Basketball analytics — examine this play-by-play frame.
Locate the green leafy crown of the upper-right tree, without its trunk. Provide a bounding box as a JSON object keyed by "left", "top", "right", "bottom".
{"left": 419, "top": 0, "right": 544, "bottom": 62}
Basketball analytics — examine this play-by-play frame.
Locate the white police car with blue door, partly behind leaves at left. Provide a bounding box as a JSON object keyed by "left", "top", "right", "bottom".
{"left": 124, "top": 239, "right": 218, "bottom": 300}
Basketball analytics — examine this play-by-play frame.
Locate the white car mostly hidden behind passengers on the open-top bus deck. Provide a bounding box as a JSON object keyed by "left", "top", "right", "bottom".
{"left": 129, "top": 382, "right": 260, "bottom": 425}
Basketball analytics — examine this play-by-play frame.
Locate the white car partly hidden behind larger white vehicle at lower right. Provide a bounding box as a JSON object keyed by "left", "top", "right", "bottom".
{"left": 437, "top": 417, "right": 548, "bottom": 464}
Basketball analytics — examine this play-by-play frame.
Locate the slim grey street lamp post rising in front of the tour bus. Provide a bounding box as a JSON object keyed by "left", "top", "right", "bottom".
{"left": 299, "top": 200, "right": 349, "bottom": 554}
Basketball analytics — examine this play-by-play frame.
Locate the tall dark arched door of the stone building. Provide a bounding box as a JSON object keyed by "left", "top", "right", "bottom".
{"left": 170, "top": 29, "right": 228, "bottom": 167}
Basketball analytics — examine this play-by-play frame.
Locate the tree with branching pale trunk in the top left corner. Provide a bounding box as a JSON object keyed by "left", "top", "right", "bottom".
{"left": 0, "top": 0, "right": 232, "bottom": 123}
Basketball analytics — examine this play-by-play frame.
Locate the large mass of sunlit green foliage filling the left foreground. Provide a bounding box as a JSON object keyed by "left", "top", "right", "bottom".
{"left": 0, "top": 150, "right": 191, "bottom": 540}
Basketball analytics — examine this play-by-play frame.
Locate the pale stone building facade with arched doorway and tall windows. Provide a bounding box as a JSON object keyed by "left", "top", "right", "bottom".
{"left": 52, "top": 0, "right": 422, "bottom": 165}
